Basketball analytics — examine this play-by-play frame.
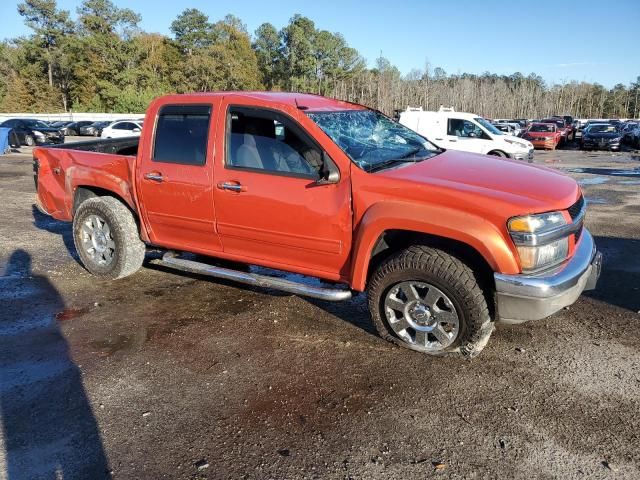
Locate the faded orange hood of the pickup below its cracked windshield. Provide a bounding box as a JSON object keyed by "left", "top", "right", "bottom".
{"left": 379, "top": 150, "right": 580, "bottom": 213}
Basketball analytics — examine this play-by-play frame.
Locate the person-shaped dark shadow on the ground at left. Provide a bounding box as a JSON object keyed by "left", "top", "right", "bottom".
{"left": 0, "top": 250, "right": 111, "bottom": 480}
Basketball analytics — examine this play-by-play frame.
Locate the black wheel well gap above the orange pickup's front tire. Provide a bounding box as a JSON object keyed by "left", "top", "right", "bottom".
{"left": 367, "top": 230, "right": 495, "bottom": 316}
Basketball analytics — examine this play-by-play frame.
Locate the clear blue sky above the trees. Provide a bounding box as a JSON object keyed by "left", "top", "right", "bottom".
{"left": 0, "top": 0, "right": 640, "bottom": 88}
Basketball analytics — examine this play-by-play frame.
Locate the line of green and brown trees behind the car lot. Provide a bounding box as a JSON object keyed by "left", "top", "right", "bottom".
{"left": 0, "top": 0, "right": 640, "bottom": 118}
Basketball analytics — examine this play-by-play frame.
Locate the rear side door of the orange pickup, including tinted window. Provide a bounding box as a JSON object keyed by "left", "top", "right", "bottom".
{"left": 136, "top": 102, "right": 222, "bottom": 253}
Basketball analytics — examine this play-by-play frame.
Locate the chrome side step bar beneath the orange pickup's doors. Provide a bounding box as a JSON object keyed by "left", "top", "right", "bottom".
{"left": 153, "top": 252, "right": 351, "bottom": 302}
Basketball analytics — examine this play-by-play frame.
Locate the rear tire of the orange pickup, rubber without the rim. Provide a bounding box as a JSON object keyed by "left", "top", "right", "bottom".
{"left": 73, "top": 197, "right": 145, "bottom": 280}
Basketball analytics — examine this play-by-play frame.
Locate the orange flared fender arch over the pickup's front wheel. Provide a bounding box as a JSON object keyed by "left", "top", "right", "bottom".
{"left": 351, "top": 202, "right": 520, "bottom": 291}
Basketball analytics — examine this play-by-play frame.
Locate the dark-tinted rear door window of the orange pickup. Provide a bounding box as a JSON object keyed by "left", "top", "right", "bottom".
{"left": 152, "top": 105, "right": 211, "bottom": 165}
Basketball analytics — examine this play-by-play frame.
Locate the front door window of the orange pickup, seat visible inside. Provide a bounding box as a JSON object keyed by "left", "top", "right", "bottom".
{"left": 225, "top": 107, "right": 322, "bottom": 178}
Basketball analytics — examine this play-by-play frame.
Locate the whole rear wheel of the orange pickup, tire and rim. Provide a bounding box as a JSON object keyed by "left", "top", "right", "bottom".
{"left": 73, "top": 197, "right": 145, "bottom": 279}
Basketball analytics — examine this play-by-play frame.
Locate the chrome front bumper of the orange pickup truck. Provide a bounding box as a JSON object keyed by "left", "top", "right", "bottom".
{"left": 494, "top": 228, "right": 602, "bottom": 323}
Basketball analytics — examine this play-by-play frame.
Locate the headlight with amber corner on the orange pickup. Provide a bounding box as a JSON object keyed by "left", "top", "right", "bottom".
{"left": 508, "top": 212, "right": 569, "bottom": 271}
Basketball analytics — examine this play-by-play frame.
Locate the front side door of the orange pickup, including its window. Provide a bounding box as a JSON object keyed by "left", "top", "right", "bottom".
{"left": 214, "top": 102, "right": 352, "bottom": 280}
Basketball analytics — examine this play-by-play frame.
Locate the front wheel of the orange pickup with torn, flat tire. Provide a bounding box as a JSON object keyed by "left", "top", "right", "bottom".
{"left": 368, "top": 245, "right": 494, "bottom": 357}
